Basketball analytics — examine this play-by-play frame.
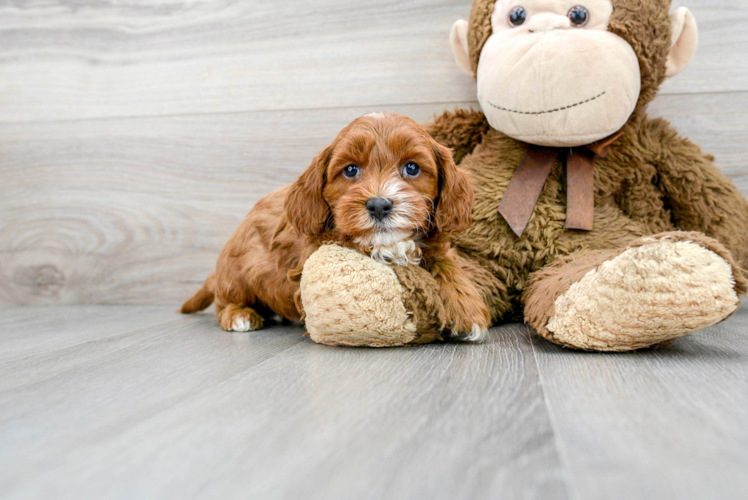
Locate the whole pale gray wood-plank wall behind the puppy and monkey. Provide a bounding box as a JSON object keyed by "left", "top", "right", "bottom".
{"left": 0, "top": 0, "right": 748, "bottom": 305}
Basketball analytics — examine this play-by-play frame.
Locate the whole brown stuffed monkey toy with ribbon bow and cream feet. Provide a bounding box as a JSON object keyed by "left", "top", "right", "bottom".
{"left": 301, "top": 0, "right": 748, "bottom": 351}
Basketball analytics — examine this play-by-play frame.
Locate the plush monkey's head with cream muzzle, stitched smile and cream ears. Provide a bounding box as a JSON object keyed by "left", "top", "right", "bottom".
{"left": 451, "top": 0, "right": 698, "bottom": 147}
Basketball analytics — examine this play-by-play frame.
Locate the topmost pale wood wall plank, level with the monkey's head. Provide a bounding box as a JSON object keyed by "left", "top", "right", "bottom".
{"left": 0, "top": 0, "right": 748, "bottom": 122}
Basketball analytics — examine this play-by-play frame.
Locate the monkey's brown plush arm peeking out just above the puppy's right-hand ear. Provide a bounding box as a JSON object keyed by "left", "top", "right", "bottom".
{"left": 424, "top": 109, "right": 490, "bottom": 164}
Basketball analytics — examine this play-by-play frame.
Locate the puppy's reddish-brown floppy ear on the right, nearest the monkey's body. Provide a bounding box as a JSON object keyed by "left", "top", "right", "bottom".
{"left": 432, "top": 141, "right": 475, "bottom": 233}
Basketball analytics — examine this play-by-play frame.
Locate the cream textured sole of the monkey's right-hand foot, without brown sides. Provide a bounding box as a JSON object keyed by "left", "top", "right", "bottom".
{"left": 547, "top": 239, "right": 740, "bottom": 351}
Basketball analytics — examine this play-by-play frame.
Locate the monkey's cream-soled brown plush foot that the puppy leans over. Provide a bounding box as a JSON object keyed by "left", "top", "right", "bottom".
{"left": 301, "top": 245, "right": 446, "bottom": 347}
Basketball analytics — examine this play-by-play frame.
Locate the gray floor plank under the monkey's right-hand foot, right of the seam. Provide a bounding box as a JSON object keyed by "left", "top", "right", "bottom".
{"left": 534, "top": 307, "right": 748, "bottom": 500}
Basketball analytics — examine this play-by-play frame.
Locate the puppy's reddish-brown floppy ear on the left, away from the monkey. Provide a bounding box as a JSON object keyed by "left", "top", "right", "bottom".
{"left": 285, "top": 146, "right": 332, "bottom": 236}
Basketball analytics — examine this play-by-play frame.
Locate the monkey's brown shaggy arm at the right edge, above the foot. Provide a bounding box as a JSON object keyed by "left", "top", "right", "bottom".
{"left": 650, "top": 120, "right": 748, "bottom": 269}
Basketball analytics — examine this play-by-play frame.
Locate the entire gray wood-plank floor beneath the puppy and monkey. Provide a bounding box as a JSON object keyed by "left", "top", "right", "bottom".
{"left": 0, "top": 306, "right": 748, "bottom": 499}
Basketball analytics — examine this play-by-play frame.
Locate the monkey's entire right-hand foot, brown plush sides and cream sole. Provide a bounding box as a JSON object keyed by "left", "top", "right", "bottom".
{"left": 524, "top": 232, "right": 746, "bottom": 351}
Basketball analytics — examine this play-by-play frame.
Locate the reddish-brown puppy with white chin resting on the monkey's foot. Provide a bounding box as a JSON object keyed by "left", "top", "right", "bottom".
{"left": 182, "top": 113, "right": 490, "bottom": 340}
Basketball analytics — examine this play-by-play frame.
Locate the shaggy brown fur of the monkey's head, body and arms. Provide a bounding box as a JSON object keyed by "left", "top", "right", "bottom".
{"left": 420, "top": 0, "right": 748, "bottom": 346}
